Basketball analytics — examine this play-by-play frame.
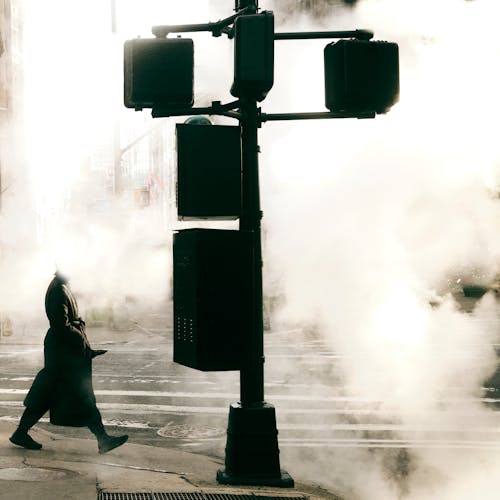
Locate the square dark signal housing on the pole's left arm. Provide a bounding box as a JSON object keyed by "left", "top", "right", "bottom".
{"left": 124, "top": 38, "right": 194, "bottom": 110}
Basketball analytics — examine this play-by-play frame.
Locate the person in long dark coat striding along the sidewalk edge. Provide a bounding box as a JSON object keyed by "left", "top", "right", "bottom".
{"left": 10, "top": 271, "right": 128, "bottom": 453}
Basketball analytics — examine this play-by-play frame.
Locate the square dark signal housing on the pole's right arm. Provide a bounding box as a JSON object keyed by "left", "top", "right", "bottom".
{"left": 324, "top": 40, "right": 399, "bottom": 113}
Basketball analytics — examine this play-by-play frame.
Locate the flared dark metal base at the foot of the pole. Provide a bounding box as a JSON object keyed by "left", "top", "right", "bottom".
{"left": 217, "top": 403, "right": 294, "bottom": 488}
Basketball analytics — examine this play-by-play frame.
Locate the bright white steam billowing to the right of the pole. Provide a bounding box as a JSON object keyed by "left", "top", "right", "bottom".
{"left": 261, "top": 0, "right": 500, "bottom": 500}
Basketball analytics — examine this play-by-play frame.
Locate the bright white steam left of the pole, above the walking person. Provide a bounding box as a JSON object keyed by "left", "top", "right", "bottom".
{"left": 0, "top": 0, "right": 191, "bottom": 324}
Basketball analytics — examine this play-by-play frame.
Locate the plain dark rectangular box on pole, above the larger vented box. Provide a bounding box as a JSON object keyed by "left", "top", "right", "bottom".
{"left": 177, "top": 123, "right": 241, "bottom": 220}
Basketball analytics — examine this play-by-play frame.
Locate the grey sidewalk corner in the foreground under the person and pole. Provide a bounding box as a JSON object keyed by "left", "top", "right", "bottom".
{"left": 0, "top": 421, "right": 339, "bottom": 500}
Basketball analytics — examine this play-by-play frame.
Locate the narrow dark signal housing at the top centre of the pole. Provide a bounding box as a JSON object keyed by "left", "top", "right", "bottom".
{"left": 231, "top": 11, "right": 274, "bottom": 101}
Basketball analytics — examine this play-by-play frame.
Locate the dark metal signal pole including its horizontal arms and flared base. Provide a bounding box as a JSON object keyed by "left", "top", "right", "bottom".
{"left": 153, "top": 6, "right": 371, "bottom": 487}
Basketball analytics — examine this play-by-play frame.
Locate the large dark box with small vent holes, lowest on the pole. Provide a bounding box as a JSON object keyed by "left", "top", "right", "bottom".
{"left": 173, "top": 229, "right": 252, "bottom": 371}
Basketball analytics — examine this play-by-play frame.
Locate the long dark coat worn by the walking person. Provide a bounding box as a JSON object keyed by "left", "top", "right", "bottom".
{"left": 24, "top": 274, "right": 96, "bottom": 427}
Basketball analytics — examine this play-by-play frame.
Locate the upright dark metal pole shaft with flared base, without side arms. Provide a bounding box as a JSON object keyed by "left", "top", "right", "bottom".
{"left": 217, "top": 0, "right": 294, "bottom": 488}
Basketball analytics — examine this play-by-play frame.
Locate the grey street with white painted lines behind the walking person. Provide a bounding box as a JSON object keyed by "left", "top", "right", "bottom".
{"left": 0, "top": 310, "right": 500, "bottom": 494}
